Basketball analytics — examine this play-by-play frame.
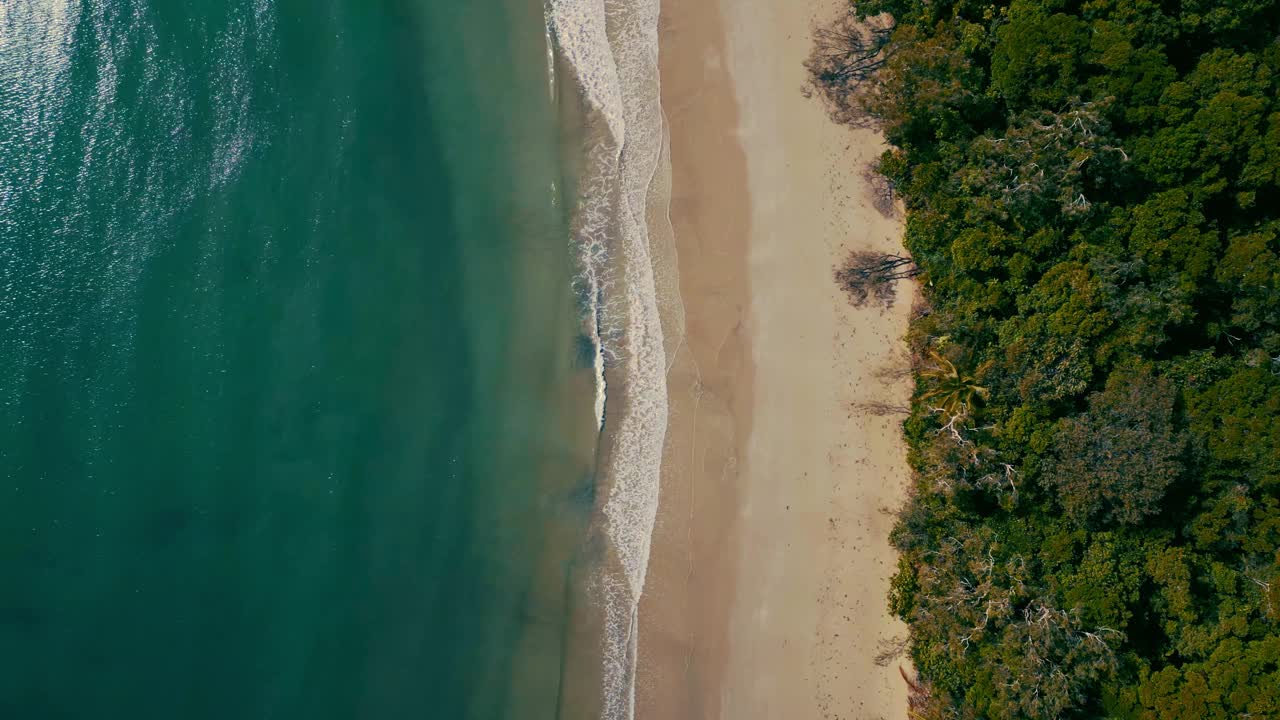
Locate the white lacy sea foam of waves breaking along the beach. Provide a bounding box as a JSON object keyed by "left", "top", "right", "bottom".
{"left": 548, "top": 0, "right": 667, "bottom": 720}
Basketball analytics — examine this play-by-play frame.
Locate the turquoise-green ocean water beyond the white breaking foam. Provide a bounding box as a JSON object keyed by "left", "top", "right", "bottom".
{"left": 0, "top": 0, "right": 595, "bottom": 720}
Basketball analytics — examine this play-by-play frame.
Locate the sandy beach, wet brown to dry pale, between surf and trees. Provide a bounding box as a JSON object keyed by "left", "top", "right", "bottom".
{"left": 636, "top": 0, "right": 910, "bottom": 720}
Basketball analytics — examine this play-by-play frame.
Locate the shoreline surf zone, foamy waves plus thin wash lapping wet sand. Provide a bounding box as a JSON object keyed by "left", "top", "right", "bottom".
{"left": 544, "top": 0, "right": 678, "bottom": 720}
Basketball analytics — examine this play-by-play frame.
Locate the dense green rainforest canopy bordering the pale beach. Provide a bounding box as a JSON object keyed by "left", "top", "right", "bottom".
{"left": 808, "top": 0, "right": 1280, "bottom": 720}
